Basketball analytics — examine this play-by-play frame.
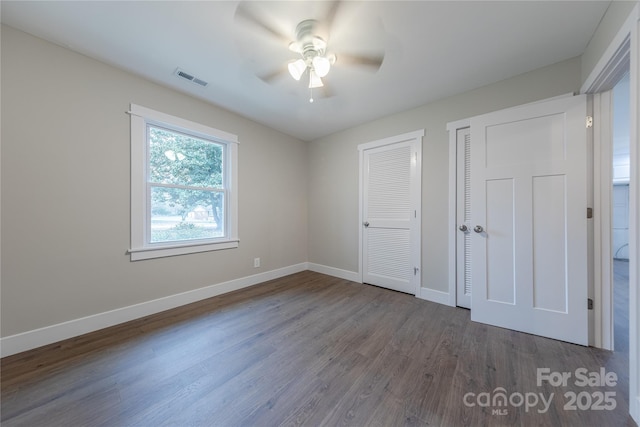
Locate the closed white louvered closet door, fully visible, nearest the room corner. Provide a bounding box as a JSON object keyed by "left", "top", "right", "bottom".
{"left": 362, "top": 143, "right": 416, "bottom": 295}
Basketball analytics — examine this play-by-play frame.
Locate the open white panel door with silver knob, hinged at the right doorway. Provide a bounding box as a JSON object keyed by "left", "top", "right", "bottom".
{"left": 470, "top": 95, "right": 588, "bottom": 345}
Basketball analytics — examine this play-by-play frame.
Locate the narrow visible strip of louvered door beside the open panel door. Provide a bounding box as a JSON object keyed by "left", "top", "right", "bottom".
{"left": 456, "top": 128, "right": 473, "bottom": 308}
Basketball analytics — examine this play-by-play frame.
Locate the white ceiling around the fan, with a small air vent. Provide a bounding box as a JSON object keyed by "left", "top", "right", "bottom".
{"left": 1, "top": 0, "right": 610, "bottom": 141}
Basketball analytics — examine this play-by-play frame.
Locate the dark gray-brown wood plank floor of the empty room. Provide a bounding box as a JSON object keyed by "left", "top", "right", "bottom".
{"left": 1, "top": 272, "right": 635, "bottom": 427}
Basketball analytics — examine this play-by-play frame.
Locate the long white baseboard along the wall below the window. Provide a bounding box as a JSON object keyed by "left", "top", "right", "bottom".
{"left": 0, "top": 262, "right": 309, "bottom": 357}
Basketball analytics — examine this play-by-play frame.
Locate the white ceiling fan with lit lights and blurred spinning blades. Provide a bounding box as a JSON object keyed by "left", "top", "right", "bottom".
{"left": 236, "top": 0, "right": 384, "bottom": 102}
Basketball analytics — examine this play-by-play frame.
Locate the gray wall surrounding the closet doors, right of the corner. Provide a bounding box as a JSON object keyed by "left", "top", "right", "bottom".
{"left": 309, "top": 58, "right": 581, "bottom": 291}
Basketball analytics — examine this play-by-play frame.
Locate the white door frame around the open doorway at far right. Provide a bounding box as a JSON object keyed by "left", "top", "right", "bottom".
{"left": 580, "top": 3, "right": 640, "bottom": 423}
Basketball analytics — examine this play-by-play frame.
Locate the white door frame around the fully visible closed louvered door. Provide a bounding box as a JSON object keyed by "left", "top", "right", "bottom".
{"left": 358, "top": 129, "right": 425, "bottom": 297}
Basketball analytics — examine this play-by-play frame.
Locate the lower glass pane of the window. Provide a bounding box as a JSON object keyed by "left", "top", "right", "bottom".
{"left": 150, "top": 187, "right": 225, "bottom": 243}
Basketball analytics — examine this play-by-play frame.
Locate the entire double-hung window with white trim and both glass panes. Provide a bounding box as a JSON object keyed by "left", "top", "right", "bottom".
{"left": 129, "top": 104, "right": 238, "bottom": 261}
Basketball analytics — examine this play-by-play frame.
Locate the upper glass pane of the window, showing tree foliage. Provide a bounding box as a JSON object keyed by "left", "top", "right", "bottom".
{"left": 147, "top": 126, "right": 223, "bottom": 188}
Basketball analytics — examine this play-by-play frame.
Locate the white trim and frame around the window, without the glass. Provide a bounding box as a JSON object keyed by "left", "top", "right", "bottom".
{"left": 128, "top": 104, "right": 240, "bottom": 261}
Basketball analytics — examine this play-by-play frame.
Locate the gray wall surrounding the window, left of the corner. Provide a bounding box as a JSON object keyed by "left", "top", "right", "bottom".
{"left": 1, "top": 26, "right": 308, "bottom": 336}
